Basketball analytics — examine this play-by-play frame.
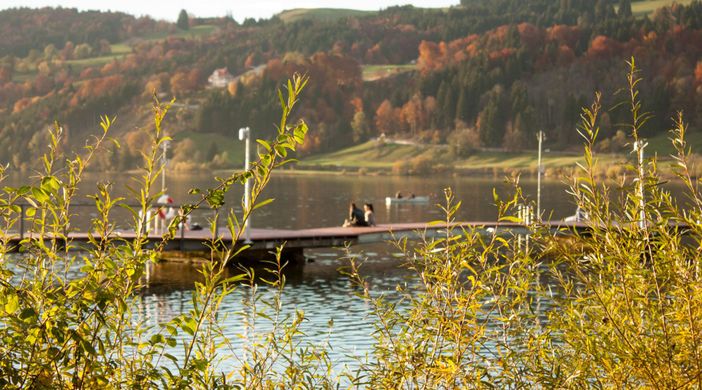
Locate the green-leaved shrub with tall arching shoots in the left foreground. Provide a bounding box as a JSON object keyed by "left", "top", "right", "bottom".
{"left": 0, "top": 77, "right": 338, "bottom": 389}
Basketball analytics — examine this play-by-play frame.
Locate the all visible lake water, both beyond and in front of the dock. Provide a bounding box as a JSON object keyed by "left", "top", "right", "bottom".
{"left": 5, "top": 174, "right": 574, "bottom": 371}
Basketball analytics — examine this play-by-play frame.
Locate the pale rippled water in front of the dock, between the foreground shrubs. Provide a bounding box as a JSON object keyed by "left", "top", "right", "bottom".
{"left": 140, "top": 244, "right": 409, "bottom": 371}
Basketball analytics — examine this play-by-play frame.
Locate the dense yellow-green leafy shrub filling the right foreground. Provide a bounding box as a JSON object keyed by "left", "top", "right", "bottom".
{"left": 349, "top": 60, "right": 702, "bottom": 389}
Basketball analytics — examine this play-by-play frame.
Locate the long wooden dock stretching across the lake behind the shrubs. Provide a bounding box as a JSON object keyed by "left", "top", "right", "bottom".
{"left": 6, "top": 221, "right": 587, "bottom": 260}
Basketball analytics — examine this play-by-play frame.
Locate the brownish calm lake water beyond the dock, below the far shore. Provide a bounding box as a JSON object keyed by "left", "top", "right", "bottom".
{"left": 71, "top": 173, "right": 575, "bottom": 229}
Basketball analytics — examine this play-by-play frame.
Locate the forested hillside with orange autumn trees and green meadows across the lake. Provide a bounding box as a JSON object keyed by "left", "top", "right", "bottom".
{"left": 0, "top": 0, "right": 702, "bottom": 169}
